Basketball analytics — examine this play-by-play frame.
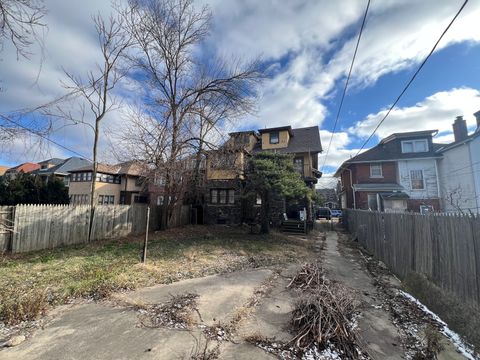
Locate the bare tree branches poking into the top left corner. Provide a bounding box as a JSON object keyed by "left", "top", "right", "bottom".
{"left": 0, "top": 0, "right": 46, "bottom": 58}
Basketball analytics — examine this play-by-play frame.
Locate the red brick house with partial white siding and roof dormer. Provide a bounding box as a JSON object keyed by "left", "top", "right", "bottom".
{"left": 335, "top": 130, "right": 442, "bottom": 212}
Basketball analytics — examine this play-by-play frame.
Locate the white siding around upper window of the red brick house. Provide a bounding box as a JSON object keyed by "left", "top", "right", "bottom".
{"left": 398, "top": 159, "right": 438, "bottom": 199}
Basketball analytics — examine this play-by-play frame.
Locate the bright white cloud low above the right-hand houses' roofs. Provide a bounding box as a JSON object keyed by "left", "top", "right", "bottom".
{"left": 348, "top": 88, "right": 480, "bottom": 142}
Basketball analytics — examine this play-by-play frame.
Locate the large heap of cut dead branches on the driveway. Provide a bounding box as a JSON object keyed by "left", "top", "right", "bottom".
{"left": 289, "top": 263, "right": 364, "bottom": 359}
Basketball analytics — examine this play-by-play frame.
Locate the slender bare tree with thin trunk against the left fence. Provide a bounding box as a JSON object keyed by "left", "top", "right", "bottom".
{"left": 45, "top": 11, "right": 132, "bottom": 241}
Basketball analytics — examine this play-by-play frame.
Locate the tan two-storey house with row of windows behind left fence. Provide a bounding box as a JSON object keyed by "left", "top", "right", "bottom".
{"left": 68, "top": 161, "right": 148, "bottom": 205}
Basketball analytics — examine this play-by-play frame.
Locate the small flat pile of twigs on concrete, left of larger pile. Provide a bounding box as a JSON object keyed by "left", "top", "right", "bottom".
{"left": 140, "top": 293, "right": 200, "bottom": 329}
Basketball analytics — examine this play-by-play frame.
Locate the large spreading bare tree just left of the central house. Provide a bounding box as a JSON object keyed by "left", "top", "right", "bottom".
{"left": 125, "top": 0, "right": 259, "bottom": 228}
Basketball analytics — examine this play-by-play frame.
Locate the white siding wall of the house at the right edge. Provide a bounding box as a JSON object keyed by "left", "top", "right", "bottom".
{"left": 438, "top": 144, "right": 480, "bottom": 212}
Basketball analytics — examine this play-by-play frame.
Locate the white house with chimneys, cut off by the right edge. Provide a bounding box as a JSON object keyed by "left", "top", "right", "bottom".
{"left": 438, "top": 111, "right": 480, "bottom": 213}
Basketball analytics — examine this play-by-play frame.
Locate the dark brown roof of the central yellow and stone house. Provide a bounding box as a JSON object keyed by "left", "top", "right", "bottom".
{"left": 253, "top": 126, "right": 322, "bottom": 154}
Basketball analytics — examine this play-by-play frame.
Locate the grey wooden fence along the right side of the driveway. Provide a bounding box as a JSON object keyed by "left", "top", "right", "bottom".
{"left": 344, "top": 210, "right": 480, "bottom": 307}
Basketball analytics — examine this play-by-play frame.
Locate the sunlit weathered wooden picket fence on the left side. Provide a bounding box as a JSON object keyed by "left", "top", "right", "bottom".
{"left": 0, "top": 204, "right": 190, "bottom": 253}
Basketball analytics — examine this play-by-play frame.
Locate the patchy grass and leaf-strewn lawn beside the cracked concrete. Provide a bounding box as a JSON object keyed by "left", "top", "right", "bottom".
{"left": 0, "top": 226, "right": 308, "bottom": 324}
